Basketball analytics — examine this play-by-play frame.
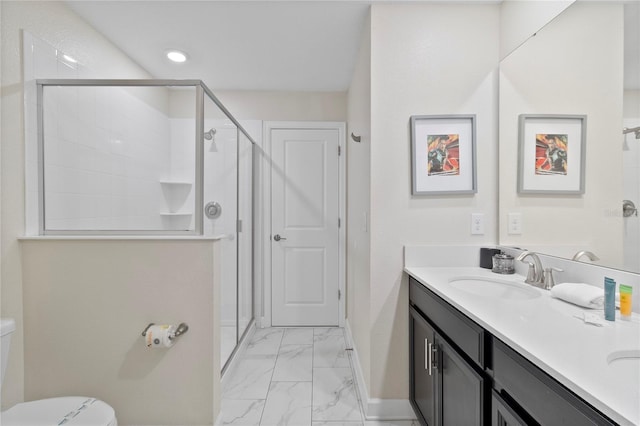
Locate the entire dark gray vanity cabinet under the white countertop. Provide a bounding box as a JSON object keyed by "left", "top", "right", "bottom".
{"left": 409, "top": 277, "right": 616, "bottom": 426}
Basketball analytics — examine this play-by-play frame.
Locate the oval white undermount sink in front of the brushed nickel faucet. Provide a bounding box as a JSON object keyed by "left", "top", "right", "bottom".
{"left": 449, "top": 277, "right": 540, "bottom": 300}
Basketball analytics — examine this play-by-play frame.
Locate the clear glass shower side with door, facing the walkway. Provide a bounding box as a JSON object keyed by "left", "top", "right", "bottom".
{"left": 203, "top": 114, "right": 253, "bottom": 369}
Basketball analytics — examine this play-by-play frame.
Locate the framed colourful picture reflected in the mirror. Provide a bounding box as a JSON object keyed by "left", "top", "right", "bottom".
{"left": 518, "top": 114, "right": 587, "bottom": 194}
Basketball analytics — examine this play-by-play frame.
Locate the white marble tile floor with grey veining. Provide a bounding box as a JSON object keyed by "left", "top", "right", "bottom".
{"left": 217, "top": 328, "right": 418, "bottom": 426}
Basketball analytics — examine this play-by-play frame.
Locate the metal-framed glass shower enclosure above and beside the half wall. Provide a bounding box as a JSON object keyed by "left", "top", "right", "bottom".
{"left": 35, "top": 79, "right": 255, "bottom": 369}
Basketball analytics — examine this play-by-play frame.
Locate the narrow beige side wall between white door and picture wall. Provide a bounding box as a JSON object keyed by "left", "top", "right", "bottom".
{"left": 347, "top": 11, "right": 371, "bottom": 392}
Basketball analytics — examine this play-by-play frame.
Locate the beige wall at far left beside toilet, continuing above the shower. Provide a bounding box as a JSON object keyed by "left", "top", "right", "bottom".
{"left": 0, "top": 0, "right": 148, "bottom": 408}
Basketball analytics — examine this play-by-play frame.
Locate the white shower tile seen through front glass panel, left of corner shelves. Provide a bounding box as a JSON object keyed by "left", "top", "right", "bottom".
{"left": 44, "top": 87, "right": 170, "bottom": 229}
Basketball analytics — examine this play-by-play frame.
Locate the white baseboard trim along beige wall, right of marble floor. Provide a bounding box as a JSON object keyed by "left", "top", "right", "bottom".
{"left": 344, "top": 318, "right": 416, "bottom": 421}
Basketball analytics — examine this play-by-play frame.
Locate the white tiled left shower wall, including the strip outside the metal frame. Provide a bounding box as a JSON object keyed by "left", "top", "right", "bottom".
{"left": 23, "top": 32, "right": 180, "bottom": 235}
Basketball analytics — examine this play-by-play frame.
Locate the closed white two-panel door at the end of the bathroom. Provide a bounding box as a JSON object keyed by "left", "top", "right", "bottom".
{"left": 271, "top": 129, "right": 340, "bottom": 326}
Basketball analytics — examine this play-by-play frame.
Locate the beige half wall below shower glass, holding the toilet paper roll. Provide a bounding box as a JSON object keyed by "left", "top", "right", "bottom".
{"left": 22, "top": 240, "right": 220, "bottom": 425}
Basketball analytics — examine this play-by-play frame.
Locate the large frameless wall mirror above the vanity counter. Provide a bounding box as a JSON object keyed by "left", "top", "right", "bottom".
{"left": 499, "top": 0, "right": 640, "bottom": 272}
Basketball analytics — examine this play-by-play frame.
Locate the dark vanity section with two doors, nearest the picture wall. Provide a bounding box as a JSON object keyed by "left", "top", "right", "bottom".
{"left": 409, "top": 274, "right": 486, "bottom": 426}
